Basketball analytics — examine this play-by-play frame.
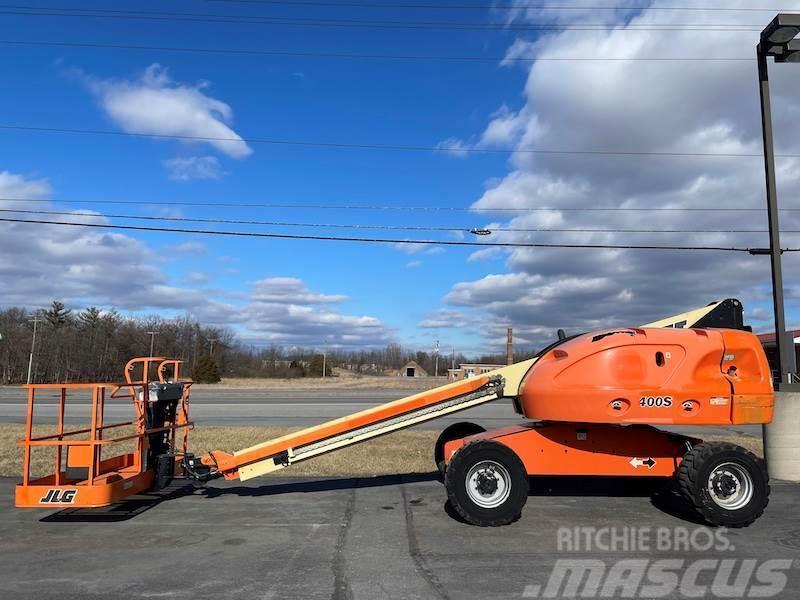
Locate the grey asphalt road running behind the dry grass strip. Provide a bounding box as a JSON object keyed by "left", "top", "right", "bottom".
{"left": 0, "top": 386, "right": 761, "bottom": 437}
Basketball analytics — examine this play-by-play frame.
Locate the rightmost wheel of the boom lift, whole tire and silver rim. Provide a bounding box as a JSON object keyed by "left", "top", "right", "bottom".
{"left": 678, "top": 442, "right": 770, "bottom": 527}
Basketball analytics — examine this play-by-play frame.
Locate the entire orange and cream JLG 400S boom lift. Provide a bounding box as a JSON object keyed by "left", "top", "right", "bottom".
{"left": 16, "top": 300, "right": 774, "bottom": 527}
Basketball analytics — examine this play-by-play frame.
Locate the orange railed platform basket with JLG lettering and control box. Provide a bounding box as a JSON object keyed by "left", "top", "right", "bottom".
{"left": 16, "top": 357, "right": 192, "bottom": 507}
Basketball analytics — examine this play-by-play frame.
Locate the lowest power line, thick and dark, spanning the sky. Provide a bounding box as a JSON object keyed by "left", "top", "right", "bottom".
{"left": 0, "top": 217, "right": 780, "bottom": 252}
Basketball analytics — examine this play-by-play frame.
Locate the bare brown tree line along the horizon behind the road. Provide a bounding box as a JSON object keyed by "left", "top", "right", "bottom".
{"left": 0, "top": 301, "right": 530, "bottom": 384}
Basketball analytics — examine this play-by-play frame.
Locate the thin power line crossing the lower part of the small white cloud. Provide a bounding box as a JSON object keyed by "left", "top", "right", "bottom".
{"left": 0, "top": 124, "right": 800, "bottom": 158}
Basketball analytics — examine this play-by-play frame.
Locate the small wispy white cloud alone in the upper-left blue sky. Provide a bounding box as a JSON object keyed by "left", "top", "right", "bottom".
{"left": 83, "top": 63, "right": 253, "bottom": 158}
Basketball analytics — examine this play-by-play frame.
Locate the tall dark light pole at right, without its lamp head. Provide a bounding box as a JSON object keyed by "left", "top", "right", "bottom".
{"left": 756, "top": 50, "right": 794, "bottom": 389}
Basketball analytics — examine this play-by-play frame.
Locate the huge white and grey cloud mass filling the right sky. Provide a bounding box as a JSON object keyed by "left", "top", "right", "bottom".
{"left": 434, "top": 0, "right": 800, "bottom": 344}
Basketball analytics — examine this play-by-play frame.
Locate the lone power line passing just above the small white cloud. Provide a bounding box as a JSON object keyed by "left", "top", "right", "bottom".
{"left": 0, "top": 40, "right": 756, "bottom": 63}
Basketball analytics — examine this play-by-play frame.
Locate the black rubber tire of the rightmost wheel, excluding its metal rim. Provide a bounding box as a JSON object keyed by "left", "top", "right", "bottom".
{"left": 677, "top": 442, "right": 770, "bottom": 527}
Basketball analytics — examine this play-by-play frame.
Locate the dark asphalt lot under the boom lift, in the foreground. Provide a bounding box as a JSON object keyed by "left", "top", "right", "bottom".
{"left": 0, "top": 475, "right": 800, "bottom": 600}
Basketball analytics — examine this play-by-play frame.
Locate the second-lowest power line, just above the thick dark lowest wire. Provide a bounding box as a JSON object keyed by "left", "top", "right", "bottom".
{"left": 0, "top": 208, "right": 800, "bottom": 235}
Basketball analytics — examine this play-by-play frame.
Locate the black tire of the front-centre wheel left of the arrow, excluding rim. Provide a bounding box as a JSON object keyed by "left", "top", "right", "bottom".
{"left": 444, "top": 440, "right": 528, "bottom": 527}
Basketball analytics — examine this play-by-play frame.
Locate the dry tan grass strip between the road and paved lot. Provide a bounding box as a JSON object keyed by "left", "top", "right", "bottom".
{"left": 0, "top": 424, "right": 762, "bottom": 477}
